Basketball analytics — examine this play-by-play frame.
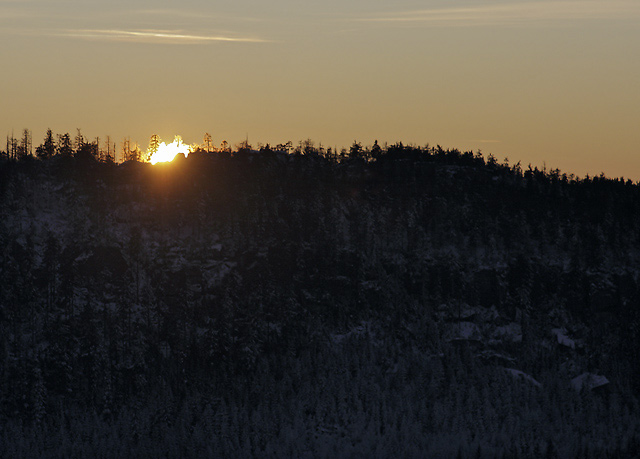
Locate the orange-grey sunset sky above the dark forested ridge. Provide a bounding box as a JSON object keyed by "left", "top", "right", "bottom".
{"left": 0, "top": 0, "right": 640, "bottom": 181}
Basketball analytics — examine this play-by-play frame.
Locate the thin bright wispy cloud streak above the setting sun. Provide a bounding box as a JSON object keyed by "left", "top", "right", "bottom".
{"left": 55, "top": 29, "right": 269, "bottom": 45}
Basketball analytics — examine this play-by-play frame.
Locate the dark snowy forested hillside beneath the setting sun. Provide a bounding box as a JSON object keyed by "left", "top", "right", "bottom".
{"left": 0, "top": 130, "right": 640, "bottom": 458}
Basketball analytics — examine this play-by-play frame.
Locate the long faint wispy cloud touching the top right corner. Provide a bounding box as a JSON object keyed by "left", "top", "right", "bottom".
{"left": 358, "top": 0, "right": 640, "bottom": 26}
